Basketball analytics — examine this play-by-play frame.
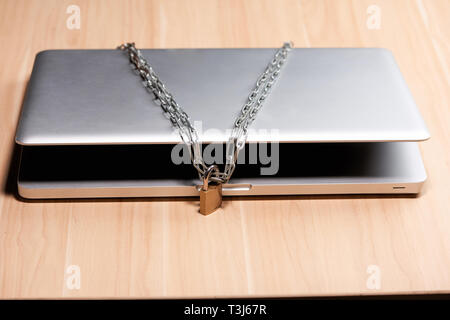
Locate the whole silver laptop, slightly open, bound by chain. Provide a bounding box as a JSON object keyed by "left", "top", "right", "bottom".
{"left": 16, "top": 48, "right": 430, "bottom": 199}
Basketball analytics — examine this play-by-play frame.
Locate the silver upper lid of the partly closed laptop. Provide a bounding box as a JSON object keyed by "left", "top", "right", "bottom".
{"left": 16, "top": 48, "right": 429, "bottom": 145}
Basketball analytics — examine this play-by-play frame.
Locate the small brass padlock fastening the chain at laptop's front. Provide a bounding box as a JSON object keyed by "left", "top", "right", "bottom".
{"left": 200, "top": 165, "right": 222, "bottom": 215}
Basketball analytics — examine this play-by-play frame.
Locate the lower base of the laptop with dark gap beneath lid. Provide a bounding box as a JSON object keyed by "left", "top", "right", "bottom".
{"left": 18, "top": 142, "right": 426, "bottom": 199}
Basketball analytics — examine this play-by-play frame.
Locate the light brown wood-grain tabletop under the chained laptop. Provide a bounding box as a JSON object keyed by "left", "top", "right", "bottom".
{"left": 0, "top": 0, "right": 450, "bottom": 298}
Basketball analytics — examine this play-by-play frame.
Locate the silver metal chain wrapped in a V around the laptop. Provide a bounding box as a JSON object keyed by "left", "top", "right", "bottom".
{"left": 118, "top": 43, "right": 292, "bottom": 183}
